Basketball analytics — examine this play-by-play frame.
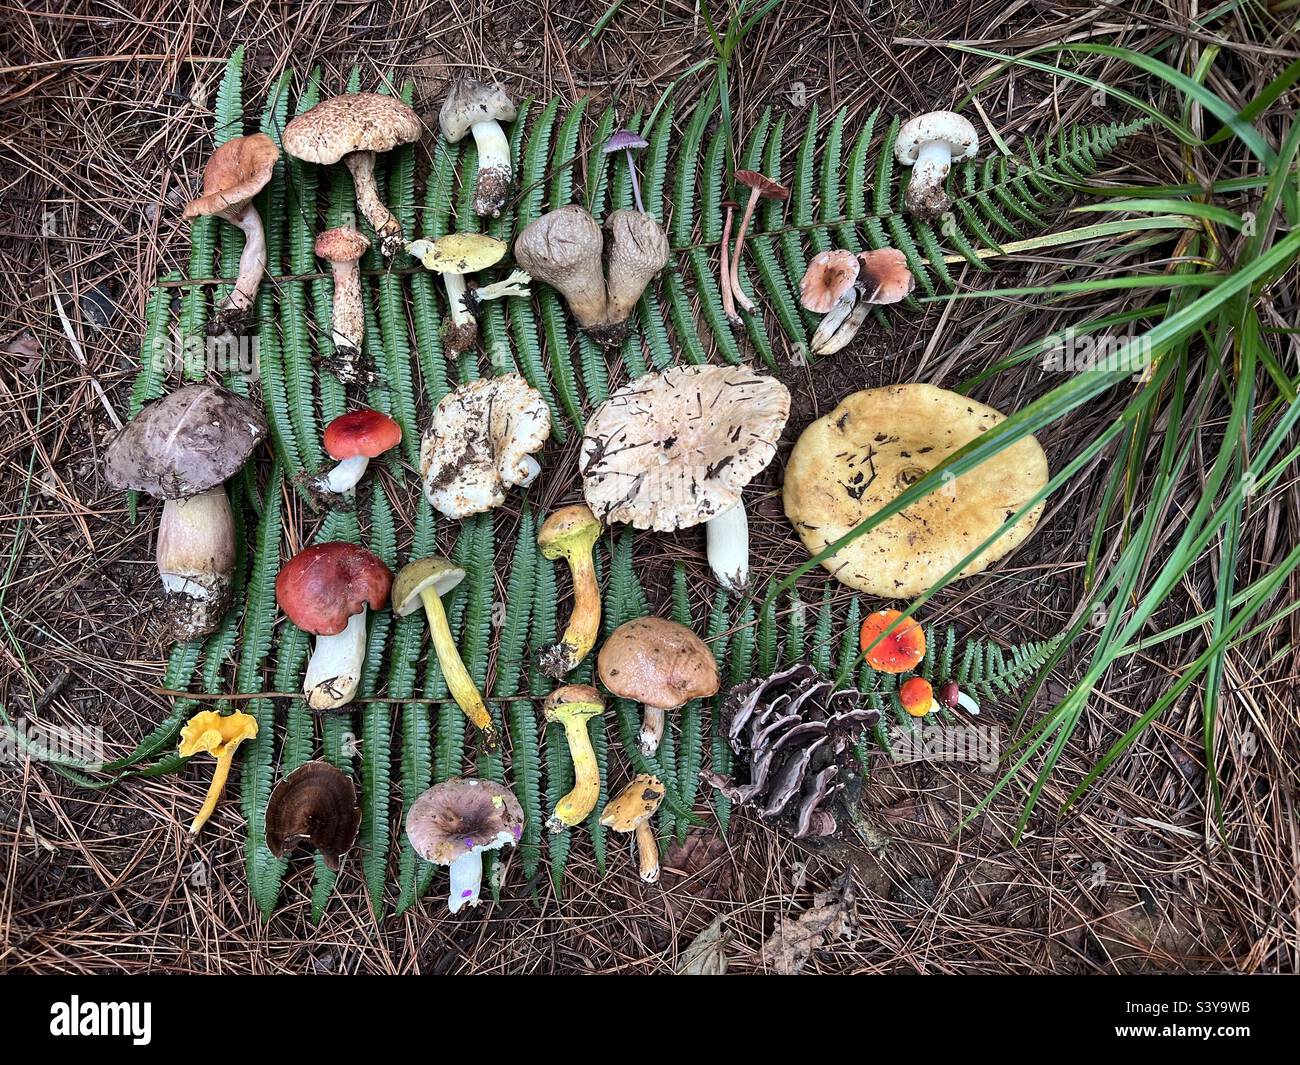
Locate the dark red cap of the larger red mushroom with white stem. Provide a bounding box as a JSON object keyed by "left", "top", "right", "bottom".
{"left": 276, "top": 542, "right": 393, "bottom": 636}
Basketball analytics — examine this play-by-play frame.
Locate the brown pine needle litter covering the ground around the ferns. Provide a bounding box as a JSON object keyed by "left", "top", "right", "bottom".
{"left": 0, "top": 0, "right": 1300, "bottom": 973}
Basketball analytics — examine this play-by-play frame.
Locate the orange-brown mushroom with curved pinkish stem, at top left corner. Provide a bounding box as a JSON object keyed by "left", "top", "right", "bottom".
{"left": 185, "top": 133, "right": 280, "bottom": 337}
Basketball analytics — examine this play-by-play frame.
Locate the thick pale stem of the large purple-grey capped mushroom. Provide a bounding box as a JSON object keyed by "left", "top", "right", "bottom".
{"left": 157, "top": 485, "right": 235, "bottom": 641}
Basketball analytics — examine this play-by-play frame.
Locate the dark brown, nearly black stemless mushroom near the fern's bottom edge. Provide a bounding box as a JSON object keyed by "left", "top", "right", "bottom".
{"left": 267, "top": 761, "right": 361, "bottom": 873}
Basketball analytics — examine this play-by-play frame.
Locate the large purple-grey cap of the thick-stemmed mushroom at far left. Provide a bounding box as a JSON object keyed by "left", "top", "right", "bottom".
{"left": 104, "top": 385, "right": 267, "bottom": 499}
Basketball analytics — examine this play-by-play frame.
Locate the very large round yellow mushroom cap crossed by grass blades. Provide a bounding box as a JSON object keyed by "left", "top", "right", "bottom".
{"left": 784, "top": 385, "right": 1048, "bottom": 598}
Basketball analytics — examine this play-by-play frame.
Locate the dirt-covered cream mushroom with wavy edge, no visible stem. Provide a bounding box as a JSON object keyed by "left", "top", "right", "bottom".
{"left": 420, "top": 373, "right": 551, "bottom": 518}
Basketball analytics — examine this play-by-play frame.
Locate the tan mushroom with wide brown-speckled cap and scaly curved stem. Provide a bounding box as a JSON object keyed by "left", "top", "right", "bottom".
{"left": 282, "top": 92, "right": 421, "bottom": 257}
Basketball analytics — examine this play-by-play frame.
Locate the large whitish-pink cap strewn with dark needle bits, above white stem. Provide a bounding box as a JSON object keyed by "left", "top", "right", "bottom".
{"left": 580, "top": 365, "right": 790, "bottom": 532}
